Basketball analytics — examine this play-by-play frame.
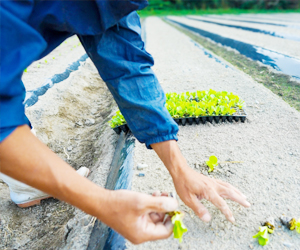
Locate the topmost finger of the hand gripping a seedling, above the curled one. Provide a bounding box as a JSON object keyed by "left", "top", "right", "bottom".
{"left": 145, "top": 196, "right": 178, "bottom": 213}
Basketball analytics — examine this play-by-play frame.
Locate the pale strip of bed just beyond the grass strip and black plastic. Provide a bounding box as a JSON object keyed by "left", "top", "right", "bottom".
{"left": 168, "top": 16, "right": 300, "bottom": 59}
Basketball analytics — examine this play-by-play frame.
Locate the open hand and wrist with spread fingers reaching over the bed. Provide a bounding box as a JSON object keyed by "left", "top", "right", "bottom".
{"left": 151, "top": 140, "right": 250, "bottom": 223}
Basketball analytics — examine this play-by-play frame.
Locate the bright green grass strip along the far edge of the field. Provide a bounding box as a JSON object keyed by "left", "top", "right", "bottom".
{"left": 138, "top": 6, "right": 300, "bottom": 17}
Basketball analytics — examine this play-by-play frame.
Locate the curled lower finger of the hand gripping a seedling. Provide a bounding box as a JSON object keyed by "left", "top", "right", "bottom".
{"left": 146, "top": 218, "right": 173, "bottom": 240}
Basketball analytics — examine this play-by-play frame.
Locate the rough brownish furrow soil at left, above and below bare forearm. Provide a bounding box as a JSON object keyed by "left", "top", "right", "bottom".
{"left": 0, "top": 50, "right": 118, "bottom": 249}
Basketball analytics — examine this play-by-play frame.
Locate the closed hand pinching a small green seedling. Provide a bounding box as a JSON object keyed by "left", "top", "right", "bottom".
{"left": 99, "top": 190, "right": 178, "bottom": 244}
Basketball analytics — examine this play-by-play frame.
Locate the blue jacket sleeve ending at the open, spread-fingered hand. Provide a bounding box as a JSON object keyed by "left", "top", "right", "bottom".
{"left": 79, "top": 12, "right": 178, "bottom": 148}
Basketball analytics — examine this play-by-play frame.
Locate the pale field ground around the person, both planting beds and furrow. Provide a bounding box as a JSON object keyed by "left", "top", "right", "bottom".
{"left": 0, "top": 14, "right": 300, "bottom": 250}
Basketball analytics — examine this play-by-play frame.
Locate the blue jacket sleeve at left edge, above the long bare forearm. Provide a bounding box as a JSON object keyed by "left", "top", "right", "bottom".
{"left": 0, "top": 1, "right": 46, "bottom": 142}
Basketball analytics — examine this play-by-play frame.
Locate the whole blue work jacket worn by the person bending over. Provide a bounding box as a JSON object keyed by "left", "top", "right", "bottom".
{"left": 0, "top": 0, "right": 178, "bottom": 148}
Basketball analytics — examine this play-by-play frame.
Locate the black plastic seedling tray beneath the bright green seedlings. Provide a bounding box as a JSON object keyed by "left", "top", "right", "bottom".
{"left": 113, "top": 108, "right": 247, "bottom": 135}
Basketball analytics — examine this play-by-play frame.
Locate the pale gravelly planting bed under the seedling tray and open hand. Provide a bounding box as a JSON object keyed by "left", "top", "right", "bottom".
{"left": 127, "top": 17, "right": 300, "bottom": 250}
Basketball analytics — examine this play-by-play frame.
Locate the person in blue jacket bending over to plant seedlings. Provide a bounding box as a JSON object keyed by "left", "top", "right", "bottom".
{"left": 0, "top": 0, "right": 250, "bottom": 244}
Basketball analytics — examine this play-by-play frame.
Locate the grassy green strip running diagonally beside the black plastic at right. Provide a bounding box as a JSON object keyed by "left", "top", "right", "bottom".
{"left": 164, "top": 20, "right": 300, "bottom": 111}
